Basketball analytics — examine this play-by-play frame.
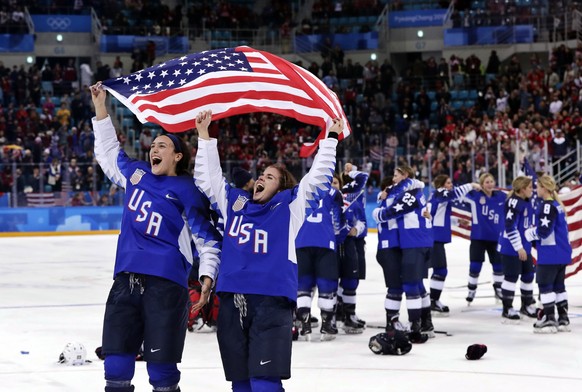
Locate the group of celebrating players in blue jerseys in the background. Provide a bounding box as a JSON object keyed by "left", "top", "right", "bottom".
{"left": 296, "top": 164, "right": 572, "bottom": 343}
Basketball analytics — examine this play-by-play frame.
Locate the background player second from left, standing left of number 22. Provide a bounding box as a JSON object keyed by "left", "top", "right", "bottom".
{"left": 336, "top": 162, "right": 369, "bottom": 334}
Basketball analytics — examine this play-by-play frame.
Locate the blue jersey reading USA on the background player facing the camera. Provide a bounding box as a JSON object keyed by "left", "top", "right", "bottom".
{"left": 464, "top": 191, "right": 507, "bottom": 242}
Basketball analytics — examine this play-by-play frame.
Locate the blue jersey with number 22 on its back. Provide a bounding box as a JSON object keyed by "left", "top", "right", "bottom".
{"left": 376, "top": 189, "right": 433, "bottom": 249}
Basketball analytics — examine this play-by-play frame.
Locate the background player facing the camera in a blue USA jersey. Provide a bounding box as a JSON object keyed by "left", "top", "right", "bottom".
{"left": 463, "top": 173, "right": 506, "bottom": 303}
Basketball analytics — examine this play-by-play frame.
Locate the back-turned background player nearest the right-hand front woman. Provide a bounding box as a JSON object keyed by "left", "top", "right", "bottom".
{"left": 295, "top": 175, "right": 343, "bottom": 341}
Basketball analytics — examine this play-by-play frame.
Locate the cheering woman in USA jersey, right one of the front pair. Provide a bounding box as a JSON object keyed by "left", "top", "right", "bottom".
{"left": 195, "top": 111, "right": 343, "bottom": 392}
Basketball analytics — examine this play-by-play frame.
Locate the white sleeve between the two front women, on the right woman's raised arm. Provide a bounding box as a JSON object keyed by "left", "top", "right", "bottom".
{"left": 194, "top": 138, "right": 228, "bottom": 221}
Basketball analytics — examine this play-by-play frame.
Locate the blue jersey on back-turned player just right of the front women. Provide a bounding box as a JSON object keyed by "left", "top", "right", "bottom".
{"left": 295, "top": 188, "right": 344, "bottom": 250}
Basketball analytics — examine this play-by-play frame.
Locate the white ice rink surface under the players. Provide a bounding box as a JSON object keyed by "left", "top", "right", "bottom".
{"left": 0, "top": 233, "right": 582, "bottom": 392}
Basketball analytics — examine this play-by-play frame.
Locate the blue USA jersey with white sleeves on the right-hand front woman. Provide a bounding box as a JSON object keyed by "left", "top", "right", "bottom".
{"left": 195, "top": 138, "right": 337, "bottom": 301}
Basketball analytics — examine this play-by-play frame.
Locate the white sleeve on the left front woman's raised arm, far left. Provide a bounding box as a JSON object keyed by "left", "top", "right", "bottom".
{"left": 91, "top": 116, "right": 127, "bottom": 189}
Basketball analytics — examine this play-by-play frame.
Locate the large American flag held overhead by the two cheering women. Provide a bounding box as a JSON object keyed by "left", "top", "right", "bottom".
{"left": 103, "top": 46, "right": 351, "bottom": 157}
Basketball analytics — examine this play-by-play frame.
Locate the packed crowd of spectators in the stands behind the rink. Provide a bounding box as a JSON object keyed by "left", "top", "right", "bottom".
{"left": 0, "top": 2, "right": 582, "bottom": 205}
